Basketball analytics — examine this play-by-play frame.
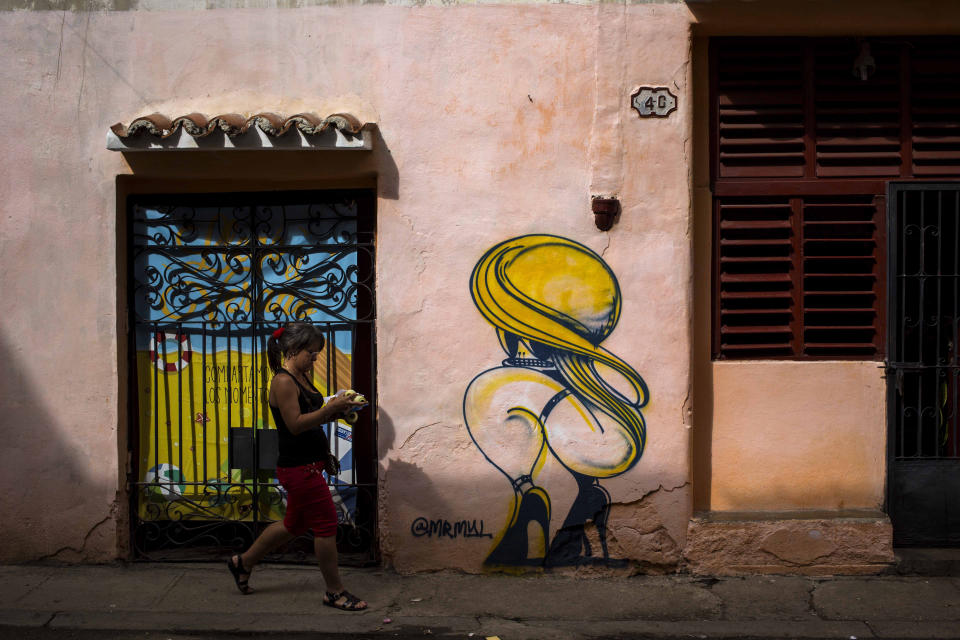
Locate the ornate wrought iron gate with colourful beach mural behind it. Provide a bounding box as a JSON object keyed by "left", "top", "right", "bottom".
{"left": 128, "top": 191, "right": 376, "bottom": 562}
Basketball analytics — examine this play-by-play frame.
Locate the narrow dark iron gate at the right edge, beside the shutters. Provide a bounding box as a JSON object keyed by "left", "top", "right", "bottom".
{"left": 887, "top": 183, "right": 960, "bottom": 545}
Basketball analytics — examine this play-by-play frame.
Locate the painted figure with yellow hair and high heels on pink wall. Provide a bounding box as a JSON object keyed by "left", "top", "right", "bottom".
{"left": 463, "top": 235, "right": 649, "bottom": 566}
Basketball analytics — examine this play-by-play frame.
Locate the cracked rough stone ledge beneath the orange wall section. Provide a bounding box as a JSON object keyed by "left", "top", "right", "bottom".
{"left": 682, "top": 511, "right": 895, "bottom": 576}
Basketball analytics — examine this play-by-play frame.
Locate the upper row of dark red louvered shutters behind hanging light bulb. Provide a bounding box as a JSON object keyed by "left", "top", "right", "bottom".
{"left": 711, "top": 37, "right": 960, "bottom": 180}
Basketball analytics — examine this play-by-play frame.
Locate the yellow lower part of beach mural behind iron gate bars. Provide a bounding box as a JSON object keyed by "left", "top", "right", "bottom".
{"left": 137, "top": 328, "right": 355, "bottom": 522}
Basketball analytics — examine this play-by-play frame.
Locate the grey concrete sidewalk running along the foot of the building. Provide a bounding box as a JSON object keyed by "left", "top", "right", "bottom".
{"left": 0, "top": 564, "right": 960, "bottom": 640}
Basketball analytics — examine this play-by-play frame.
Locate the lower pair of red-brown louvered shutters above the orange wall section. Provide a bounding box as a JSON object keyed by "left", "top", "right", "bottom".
{"left": 714, "top": 195, "right": 884, "bottom": 358}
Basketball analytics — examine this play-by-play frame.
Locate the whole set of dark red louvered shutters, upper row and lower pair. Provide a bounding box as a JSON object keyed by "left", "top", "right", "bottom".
{"left": 710, "top": 36, "right": 960, "bottom": 358}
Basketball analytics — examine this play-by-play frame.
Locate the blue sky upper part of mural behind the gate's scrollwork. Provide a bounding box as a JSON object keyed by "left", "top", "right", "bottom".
{"left": 134, "top": 204, "right": 358, "bottom": 353}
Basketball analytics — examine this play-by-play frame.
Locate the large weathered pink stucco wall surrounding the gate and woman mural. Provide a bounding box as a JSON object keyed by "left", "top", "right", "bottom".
{"left": 0, "top": 4, "right": 692, "bottom": 571}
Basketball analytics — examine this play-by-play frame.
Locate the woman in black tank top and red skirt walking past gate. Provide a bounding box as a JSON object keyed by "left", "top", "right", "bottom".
{"left": 227, "top": 322, "right": 367, "bottom": 611}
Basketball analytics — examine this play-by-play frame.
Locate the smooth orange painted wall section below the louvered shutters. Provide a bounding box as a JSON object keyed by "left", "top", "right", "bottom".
{"left": 710, "top": 361, "right": 886, "bottom": 511}
